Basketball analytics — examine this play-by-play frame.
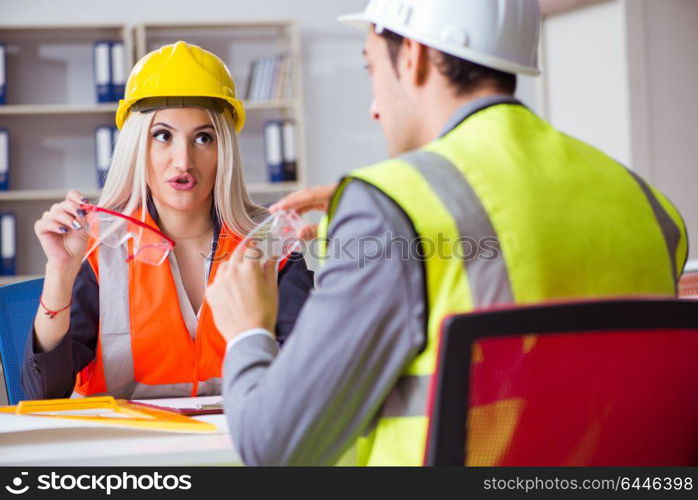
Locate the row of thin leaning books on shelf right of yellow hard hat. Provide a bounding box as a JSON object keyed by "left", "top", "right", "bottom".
{"left": 245, "top": 54, "right": 291, "bottom": 102}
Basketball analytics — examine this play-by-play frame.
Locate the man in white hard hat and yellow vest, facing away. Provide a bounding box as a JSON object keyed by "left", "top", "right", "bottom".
{"left": 207, "top": 0, "right": 687, "bottom": 465}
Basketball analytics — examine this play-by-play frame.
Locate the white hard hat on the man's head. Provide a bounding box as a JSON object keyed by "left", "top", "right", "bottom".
{"left": 339, "top": 0, "right": 541, "bottom": 75}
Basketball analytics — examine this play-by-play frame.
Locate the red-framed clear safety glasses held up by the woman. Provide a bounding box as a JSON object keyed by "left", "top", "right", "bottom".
{"left": 80, "top": 204, "right": 175, "bottom": 266}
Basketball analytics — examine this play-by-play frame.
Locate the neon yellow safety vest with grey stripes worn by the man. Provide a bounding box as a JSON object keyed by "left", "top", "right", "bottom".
{"left": 319, "top": 105, "right": 687, "bottom": 465}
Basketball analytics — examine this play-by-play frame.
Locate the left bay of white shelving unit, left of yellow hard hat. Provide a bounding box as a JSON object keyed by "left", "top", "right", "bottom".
{"left": 0, "top": 24, "right": 134, "bottom": 285}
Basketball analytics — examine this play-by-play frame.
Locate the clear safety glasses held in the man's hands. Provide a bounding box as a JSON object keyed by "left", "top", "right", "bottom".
{"left": 242, "top": 211, "right": 304, "bottom": 261}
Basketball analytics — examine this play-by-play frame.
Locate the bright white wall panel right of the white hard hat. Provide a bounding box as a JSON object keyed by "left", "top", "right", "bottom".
{"left": 541, "top": 0, "right": 632, "bottom": 167}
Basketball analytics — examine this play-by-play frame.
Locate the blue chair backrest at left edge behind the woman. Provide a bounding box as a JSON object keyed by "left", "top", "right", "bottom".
{"left": 0, "top": 278, "right": 44, "bottom": 404}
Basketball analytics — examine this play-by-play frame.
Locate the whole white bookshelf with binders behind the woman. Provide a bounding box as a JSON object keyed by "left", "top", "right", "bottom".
{"left": 0, "top": 20, "right": 306, "bottom": 286}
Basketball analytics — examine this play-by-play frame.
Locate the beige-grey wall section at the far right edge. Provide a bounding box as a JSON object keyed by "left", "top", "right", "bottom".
{"left": 625, "top": 0, "right": 698, "bottom": 265}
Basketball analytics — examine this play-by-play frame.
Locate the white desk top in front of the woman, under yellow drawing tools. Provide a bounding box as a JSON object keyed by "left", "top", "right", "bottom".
{"left": 0, "top": 397, "right": 242, "bottom": 466}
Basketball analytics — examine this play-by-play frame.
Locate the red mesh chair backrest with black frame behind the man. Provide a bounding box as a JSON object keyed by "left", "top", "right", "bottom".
{"left": 425, "top": 300, "right": 698, "bottom": 466}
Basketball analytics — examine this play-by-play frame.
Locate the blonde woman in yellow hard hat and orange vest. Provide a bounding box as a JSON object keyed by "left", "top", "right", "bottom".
{"left": 22, "top": 42, "right": 312, "bottom": 399}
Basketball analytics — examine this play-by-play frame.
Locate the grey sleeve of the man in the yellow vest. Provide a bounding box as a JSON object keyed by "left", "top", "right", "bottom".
{"left": 223, "top": 181, "right": 426, "bottom": 465}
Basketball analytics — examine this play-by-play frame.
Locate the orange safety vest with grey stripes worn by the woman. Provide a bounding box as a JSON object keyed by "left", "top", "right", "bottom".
{"left": 74, "top": 211, "right": 241, "bottom": 399}
